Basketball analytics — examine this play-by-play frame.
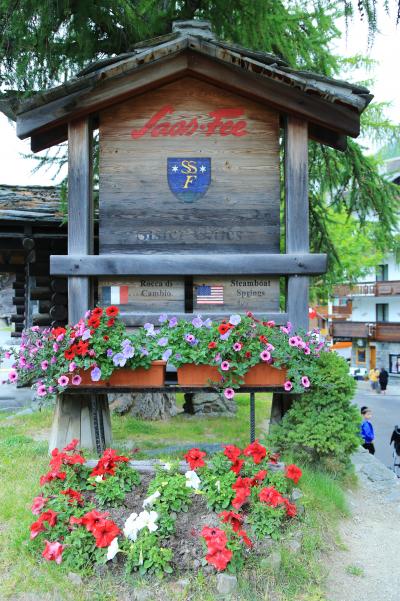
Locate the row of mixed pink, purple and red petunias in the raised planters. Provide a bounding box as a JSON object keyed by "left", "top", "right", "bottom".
{"left": 6, "top": 306, "right": 326, "bottom": 398}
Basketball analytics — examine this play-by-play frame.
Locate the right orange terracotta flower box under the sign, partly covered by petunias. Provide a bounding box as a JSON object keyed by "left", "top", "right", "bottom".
{"left": 178, "top": 363, "right": 286, "bottom": 387}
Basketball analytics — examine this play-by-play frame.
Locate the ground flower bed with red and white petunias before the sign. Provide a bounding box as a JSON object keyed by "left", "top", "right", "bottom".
{"left": 30, "top": 440, "right": 301, "bottom": 574}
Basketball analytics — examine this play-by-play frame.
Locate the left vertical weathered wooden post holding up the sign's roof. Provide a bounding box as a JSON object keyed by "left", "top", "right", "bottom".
{"left": 68, "top": 118, "right": 94, "bottom": 323}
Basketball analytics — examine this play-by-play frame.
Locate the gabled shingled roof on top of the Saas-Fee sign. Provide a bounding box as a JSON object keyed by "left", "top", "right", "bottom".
{"left": 0, "top": 20, "right": 372, "bottom": 151}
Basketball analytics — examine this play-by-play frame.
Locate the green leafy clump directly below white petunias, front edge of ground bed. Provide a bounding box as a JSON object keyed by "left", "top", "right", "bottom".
{"left": 123, "top": 531, "right": 173, "bottom": 576}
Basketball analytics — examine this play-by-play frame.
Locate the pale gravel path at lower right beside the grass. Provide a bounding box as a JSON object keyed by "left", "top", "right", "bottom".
{"left": 326, "top": 453, "right": 400, "bottom": 601}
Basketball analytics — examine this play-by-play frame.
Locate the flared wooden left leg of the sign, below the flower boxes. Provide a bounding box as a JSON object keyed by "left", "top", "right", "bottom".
{"left": 49, "top": 392, "right": 112, "bottom": 455}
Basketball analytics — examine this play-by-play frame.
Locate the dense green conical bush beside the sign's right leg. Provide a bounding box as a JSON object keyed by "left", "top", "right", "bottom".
{"left": 269, "top": 352, "right": 360, "bottom": 472}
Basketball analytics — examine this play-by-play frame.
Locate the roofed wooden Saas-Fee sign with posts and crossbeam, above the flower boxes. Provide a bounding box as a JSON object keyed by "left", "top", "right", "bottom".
{"left": 7, "top": 20, "right": 371, "bottom": 450}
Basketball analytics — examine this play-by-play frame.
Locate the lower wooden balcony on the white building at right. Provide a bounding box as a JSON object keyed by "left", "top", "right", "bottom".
{"left": 331, "top": 321, "right": 400, "bottom": 342}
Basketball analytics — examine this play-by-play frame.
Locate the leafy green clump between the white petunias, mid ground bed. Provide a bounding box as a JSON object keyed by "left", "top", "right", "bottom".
{"left": 148, "top": 471, "right": 192, "bottom": 512}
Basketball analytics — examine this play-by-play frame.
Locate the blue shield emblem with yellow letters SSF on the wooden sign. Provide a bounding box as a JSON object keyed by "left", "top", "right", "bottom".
{"left": 167, "top": 157, "right": 211, "bottom": 202}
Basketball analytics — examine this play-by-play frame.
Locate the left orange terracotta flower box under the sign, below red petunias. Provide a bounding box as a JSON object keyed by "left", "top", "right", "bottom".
{"left": 71, "top": 361, "right": 167, "bottom": 388}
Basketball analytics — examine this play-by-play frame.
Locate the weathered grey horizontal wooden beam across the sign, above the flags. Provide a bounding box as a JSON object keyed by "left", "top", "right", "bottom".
{"left": 50, "top": 253, "right": 326, "bottom": 276}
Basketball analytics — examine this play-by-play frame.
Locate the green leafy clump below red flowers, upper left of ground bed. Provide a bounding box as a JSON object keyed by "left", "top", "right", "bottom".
{"left": 96, "top": 463, "right": 140, "bottom": 507}
